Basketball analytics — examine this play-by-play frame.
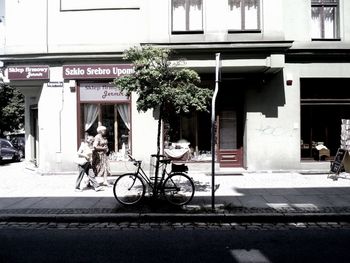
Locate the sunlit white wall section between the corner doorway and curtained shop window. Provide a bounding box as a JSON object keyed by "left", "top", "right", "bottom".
{"left": 38, "top": 67, "right": 77, "bottom": 173}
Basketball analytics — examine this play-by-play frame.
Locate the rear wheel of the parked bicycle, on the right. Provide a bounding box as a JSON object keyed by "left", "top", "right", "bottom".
{"left": 162, "top": 173, "right": 194, "bottom": 206}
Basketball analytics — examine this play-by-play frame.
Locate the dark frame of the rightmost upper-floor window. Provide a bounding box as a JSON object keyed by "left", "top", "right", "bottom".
{"left": 311, "top": 0, "right": 340, "bottom": 41}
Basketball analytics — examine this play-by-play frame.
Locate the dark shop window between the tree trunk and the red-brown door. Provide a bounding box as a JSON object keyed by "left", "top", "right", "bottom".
{"left": 164, "top": 112, "right": 211, "bottom": 161}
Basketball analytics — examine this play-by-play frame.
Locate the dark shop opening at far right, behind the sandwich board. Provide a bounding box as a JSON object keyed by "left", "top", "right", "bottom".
{"left": 300, "top": 78, "right": 350, "bottom": 161}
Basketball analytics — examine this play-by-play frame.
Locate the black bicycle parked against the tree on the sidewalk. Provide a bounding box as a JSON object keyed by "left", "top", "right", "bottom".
{"left": 113, "top": 155, "right": 195, "bottom": 206}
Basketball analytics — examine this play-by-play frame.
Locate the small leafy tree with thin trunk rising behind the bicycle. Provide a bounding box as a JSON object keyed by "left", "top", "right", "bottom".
{"left": 114, "top": 45, "right": 212, "bottom": 155}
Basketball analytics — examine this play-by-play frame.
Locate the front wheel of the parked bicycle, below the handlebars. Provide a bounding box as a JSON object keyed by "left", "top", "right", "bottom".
{"left": 113, "top": 174, "right": 145, "bottom": 205}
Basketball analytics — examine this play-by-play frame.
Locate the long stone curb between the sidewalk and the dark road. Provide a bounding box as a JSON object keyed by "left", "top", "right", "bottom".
{"left": 0, "top": 213, "right": 350, "bottom": 223}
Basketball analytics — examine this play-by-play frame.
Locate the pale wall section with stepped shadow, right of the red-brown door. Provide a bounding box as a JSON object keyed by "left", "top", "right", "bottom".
{"left": 245, "top": 69, "right": 300, "bottom": 171}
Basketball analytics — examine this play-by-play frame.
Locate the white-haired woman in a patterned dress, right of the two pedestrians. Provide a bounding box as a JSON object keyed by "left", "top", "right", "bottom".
{"left": 92, "top": 126, "right": 111, "bottom": 186}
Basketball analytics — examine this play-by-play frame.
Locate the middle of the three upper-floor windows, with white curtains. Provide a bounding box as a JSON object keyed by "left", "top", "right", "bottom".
{"left": 228, "top": 0, "right": 260, "bottom": 31}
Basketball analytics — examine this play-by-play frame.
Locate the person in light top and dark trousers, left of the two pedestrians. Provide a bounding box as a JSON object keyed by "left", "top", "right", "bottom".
{"left": 75, "top": 136, "right": 103, "bottom": 192}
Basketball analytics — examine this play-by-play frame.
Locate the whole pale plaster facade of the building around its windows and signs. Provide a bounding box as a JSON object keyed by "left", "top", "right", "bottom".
{"left": 0, "top": 0, "right": 350, "bottom": 172}
